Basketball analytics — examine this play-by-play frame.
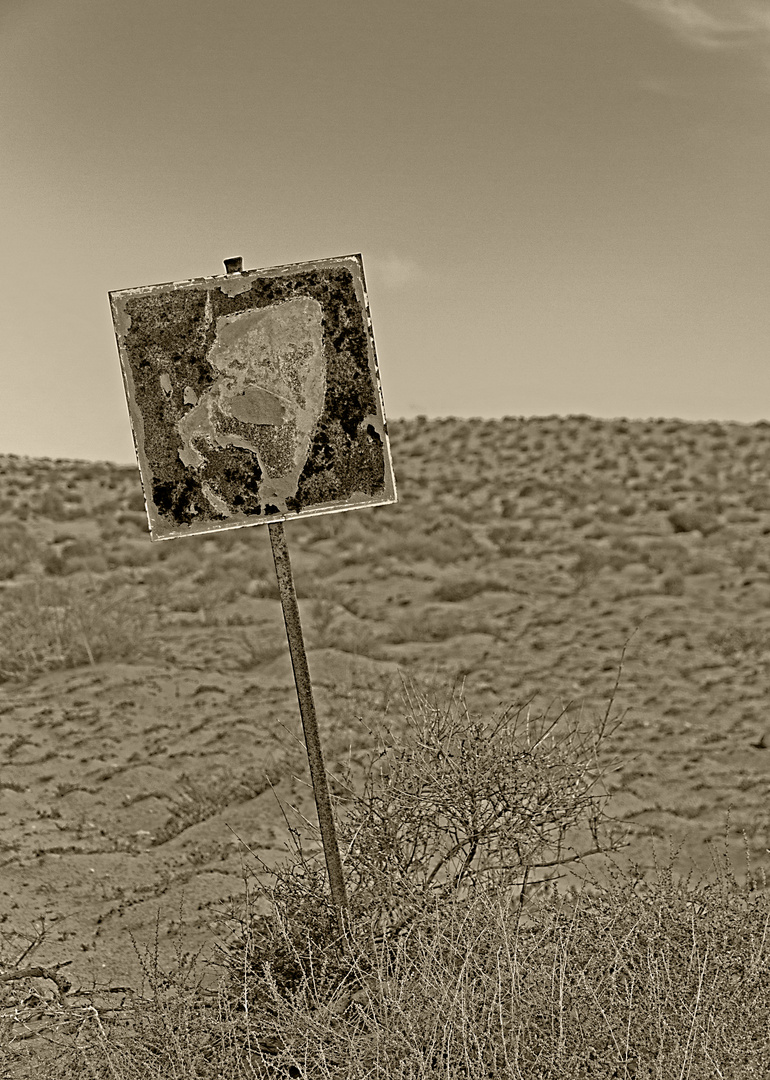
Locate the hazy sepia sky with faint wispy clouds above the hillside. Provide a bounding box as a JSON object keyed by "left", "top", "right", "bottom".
{"left": 0, "top": 0, "right": 770, "bottom": 462}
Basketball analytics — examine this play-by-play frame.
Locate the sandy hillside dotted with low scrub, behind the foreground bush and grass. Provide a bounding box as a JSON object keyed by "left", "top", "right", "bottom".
{"left": 0, "top": 416, "right": 770, "bottom": 1077}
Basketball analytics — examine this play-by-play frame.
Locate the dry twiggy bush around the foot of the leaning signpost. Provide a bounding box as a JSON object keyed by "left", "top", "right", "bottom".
{"left": 211, "top": 669, "right": 625, "bottom": 1023}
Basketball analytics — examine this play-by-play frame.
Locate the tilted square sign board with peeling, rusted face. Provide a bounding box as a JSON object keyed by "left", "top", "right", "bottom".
{"left": 110, "top": 255, "right": 396, "bottom": 540}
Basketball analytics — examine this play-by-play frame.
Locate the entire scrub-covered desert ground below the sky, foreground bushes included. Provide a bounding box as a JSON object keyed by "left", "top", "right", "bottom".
{"left": 0, "top": 417, "right": 770, "bottom": 1080}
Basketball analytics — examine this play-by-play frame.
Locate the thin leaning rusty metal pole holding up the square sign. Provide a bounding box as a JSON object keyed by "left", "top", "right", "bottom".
{"left": 225, "top": 258, "right": 348, "bottom": 943}
